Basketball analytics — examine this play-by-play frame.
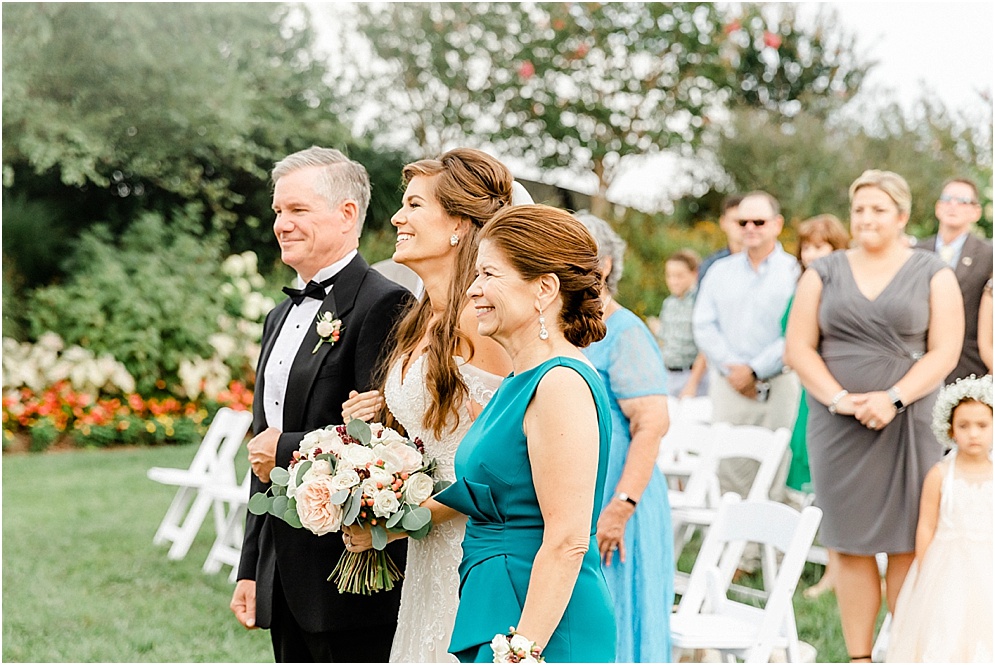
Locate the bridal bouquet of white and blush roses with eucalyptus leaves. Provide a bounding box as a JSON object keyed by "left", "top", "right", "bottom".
{"left": 248, "top": 420, "right": 446, "bottom": 595}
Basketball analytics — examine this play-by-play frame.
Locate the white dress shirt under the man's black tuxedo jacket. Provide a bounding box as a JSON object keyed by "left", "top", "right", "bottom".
{"left": 263, "top": 250, "right": 358, "bottom": 432}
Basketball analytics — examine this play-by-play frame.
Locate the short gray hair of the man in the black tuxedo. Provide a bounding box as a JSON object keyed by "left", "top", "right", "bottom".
{"left": 272, "top": 146, "right": 370, "bottom": 235}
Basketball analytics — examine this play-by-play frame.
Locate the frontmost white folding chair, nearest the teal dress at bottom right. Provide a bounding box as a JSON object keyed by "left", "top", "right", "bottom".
{"left": 670, "top": 493, "right": 822, "bottom": 663}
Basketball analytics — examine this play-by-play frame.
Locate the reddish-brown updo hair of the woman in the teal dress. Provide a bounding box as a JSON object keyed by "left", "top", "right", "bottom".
{"left": 480, "top": 205, "right": 607, "bottom": 347}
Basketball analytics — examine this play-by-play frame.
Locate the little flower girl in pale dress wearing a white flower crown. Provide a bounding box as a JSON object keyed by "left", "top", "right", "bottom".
{"left": 887, "top": 376, "right": 993, "bottom": 663}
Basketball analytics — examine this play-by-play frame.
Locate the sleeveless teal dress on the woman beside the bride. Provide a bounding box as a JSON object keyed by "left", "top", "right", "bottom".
{"left": 436, "top": 357, "right": 615, "bottom": 663}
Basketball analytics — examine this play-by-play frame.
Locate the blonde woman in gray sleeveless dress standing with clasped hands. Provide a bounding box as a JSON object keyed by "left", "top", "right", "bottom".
{"left": 785, "top": 170, "right": 964, "bottom": 661}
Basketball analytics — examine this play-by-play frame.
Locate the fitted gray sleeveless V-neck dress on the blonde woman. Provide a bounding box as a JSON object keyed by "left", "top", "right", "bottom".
{"left": 807, "top": 251, "right": 946, "bottom": 555}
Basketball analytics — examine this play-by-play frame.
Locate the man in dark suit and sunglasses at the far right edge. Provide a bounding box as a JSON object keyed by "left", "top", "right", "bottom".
{"left": 916, "top": 178, "right": 992, "bottom": 383}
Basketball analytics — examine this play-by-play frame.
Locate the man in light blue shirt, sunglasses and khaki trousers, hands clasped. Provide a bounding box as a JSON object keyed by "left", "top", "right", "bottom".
{"left": 692, "top": 191, "right": 800, "bottom": 520}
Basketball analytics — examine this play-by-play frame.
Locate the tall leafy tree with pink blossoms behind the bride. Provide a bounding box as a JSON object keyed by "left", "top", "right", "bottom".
{"left": 354, "top": 3, "right": 862, "bottom": 214}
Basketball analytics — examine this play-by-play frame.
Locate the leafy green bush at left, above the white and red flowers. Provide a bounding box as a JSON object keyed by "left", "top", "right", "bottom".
{"left": 28, "top": 207, "right": 223, "bottom": 395}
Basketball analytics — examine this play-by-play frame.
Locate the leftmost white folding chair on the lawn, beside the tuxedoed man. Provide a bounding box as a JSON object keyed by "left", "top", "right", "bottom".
{"left": 147, "top": 407, "right": 252, "bottom": 560}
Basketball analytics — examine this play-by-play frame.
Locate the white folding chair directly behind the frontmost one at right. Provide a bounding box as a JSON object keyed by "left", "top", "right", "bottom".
{"left": 671, "top": 423, "right": 791, "bottom": 595}
